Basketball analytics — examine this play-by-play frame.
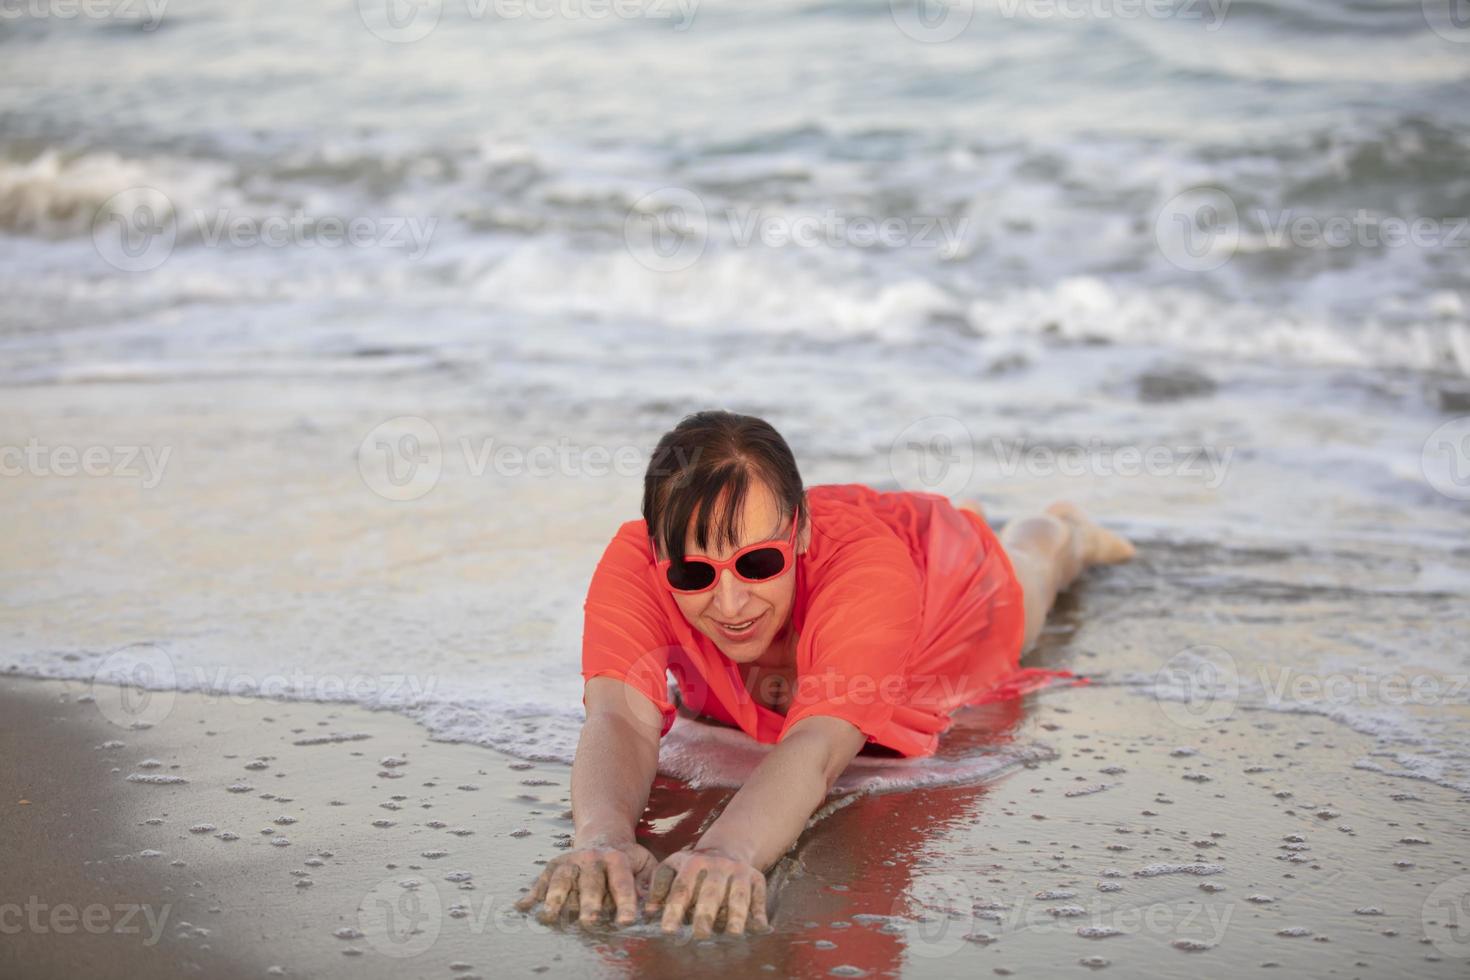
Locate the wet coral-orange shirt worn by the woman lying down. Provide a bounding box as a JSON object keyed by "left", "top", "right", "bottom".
{"left": 582, "top": 483, "right": 1072, "bottom": 755}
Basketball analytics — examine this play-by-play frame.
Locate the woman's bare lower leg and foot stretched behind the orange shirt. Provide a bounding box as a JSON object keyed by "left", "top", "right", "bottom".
{"left": 960, "top": 501, "right": 1135, "bottom": 654}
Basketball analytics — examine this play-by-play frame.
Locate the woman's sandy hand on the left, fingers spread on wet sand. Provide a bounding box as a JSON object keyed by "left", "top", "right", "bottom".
{"left": 516, "top": 837, "right": 659, "bottom": 927}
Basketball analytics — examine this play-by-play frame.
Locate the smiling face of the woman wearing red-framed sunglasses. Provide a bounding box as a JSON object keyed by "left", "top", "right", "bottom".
{"left": 673, "top": 485, "right": 807, "bottom": 664}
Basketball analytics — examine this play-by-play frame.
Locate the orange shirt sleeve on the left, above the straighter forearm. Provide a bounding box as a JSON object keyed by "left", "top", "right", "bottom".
{"left": 582, "top": 520, "right": 675, "bottom": 735}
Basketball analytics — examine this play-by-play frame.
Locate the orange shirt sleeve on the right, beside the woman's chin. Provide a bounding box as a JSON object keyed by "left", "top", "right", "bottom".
{"left": 781, "top": 538, "right": 923, "bottom": 742}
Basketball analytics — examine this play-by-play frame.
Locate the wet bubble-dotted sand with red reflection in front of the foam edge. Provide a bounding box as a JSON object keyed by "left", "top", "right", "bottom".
{"left": 0, "top": 676, "right": 1470, "bottom": 979}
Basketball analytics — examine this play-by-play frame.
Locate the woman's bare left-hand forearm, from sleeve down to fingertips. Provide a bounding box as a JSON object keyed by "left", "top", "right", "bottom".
{"left": 516, "top": 677, "right": 663, "bottom": 926}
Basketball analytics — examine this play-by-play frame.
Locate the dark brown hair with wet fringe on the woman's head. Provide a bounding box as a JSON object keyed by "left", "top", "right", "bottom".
{"left": 642, "top": 410, "right": 807, "bottom": 561}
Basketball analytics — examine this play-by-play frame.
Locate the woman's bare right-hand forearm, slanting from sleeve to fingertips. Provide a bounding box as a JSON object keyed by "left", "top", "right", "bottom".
{"left": 645, "top": 714, "right": 866, "bottom": 937}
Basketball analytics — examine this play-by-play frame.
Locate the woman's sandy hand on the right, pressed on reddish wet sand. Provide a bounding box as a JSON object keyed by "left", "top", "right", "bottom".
{"left": 644, "top": 848, "right": 770, "bottom": 939}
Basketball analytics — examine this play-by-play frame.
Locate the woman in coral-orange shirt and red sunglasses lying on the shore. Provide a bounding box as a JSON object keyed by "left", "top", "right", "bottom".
{"left": 517, "top": 411, "right": 1133, "bottom": 936}
